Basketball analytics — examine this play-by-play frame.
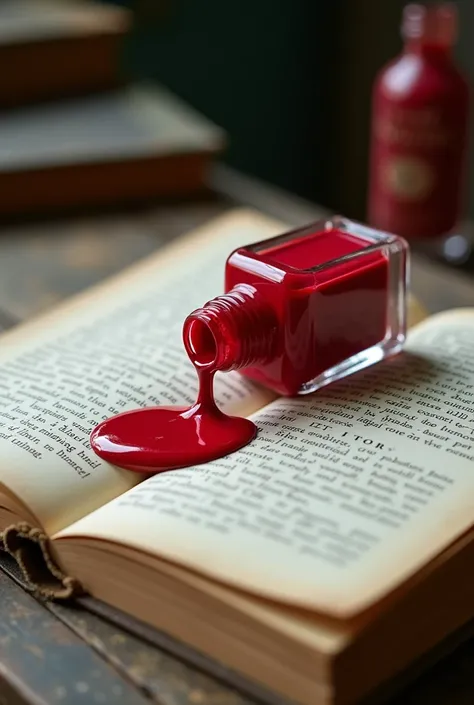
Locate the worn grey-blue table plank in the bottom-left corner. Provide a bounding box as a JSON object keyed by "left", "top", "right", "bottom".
{"left": 0, "top": 572, "right": 147, "bottom": 705}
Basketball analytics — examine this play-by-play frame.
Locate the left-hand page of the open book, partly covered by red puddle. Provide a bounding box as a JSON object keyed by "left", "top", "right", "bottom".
{"left": 0, "top": 211, "right": 281, "bottom": 532}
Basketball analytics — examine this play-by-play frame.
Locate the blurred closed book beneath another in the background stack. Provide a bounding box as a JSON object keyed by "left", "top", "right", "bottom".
{"left": 0, "top": 85, "right": 224, "bottom": 216}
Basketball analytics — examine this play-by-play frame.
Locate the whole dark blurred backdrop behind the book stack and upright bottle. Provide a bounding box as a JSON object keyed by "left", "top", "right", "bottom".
{"left": 114, "top": 0, "right": 474, "bottom": 219}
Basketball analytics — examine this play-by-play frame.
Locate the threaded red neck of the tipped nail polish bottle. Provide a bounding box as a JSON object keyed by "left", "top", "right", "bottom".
{"left": 183, "top": 284, "right": 278, "bottom": 372}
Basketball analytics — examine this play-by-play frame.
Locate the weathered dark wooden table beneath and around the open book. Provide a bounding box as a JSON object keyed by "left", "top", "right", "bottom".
{"left": 0, "top": 167, "right": 474, "bottom": 705}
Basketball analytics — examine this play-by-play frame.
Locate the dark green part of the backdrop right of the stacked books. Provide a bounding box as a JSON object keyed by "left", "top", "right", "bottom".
{"left": 108, "top": 0, "right": 339, "bottom": 202}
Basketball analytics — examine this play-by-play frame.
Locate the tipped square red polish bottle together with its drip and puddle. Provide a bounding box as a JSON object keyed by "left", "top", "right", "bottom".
{"left": 91, "top": 218, "right": 409, "bottom": 473}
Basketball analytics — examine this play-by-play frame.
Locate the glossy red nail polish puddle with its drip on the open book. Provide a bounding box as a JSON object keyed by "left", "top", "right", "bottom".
{"left": 90, "top": 368, "right": 257, "bottom": 474}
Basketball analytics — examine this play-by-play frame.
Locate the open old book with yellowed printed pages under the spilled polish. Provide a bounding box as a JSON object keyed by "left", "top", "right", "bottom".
{"left": 0, "top": 211, "right": 474, "bottom": 705}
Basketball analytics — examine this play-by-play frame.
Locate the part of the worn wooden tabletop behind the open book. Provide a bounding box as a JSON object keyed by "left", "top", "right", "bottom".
{"left": 0, "top": 168, "right": 474, "bottom": 319}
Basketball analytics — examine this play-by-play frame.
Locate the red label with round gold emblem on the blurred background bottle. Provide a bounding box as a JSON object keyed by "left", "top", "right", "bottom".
{"left": 369, "top": 95, "right": 465, "bottom": 237}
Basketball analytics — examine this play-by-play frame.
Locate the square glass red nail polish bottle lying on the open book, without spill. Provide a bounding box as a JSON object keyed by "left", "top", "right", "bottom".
{"left": 183, "top": 217, "right": 409, "bottom": 396}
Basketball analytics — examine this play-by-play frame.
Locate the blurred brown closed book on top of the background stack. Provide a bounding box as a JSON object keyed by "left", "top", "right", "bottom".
{"left": 0, "top": 0, "right": 130, "bottom": 107}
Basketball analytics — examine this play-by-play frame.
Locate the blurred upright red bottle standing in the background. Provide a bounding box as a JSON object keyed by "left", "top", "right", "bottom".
{"left": 368, "top": 3, "right": 469, "bottom": 244}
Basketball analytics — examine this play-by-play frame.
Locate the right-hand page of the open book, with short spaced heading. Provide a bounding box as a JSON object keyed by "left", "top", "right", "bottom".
{"left": 60, "top": 310, "right": 474, "bottom": 616}
